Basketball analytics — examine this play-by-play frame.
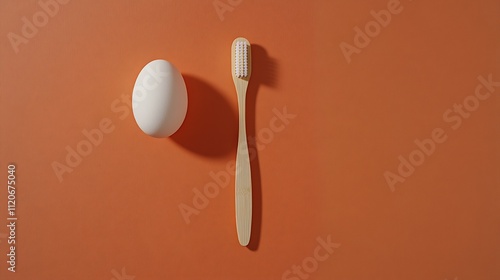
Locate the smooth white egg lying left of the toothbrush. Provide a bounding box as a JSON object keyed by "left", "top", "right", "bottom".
{"left": 132, "top": 59, "right": 187, "bottom": 138}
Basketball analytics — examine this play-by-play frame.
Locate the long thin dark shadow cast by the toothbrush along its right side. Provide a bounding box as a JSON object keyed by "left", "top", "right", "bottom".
{"left": 246, "top": 44, "right": 278, "bottom": 251}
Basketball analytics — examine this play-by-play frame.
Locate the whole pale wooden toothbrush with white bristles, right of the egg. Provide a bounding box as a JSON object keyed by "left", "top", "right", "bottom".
{"left": 231, "top": 37, "right": 252, "bottom": 246}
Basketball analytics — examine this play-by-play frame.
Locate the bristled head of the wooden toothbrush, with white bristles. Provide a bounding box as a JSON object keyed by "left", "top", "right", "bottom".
{"left": 231, "top": 37, "right": 252, "bottom": 80}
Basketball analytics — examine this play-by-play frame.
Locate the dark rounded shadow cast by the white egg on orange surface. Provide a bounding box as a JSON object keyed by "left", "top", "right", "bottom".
{"left": 169, "top": 74, "right": 238, "bottom": 157}
